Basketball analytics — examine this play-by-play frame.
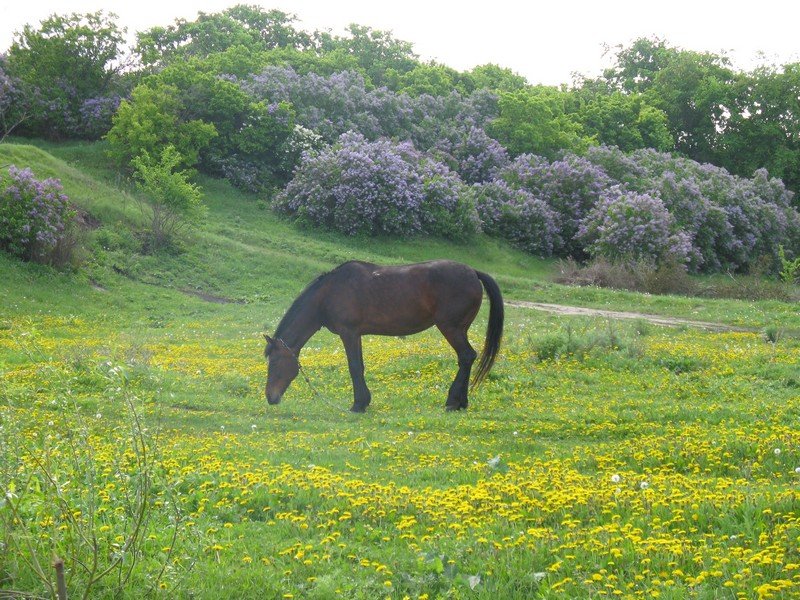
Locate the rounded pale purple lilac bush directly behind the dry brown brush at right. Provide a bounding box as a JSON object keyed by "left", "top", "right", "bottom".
{"left": 577, "top": 188, "right": 692, "bottom": 262}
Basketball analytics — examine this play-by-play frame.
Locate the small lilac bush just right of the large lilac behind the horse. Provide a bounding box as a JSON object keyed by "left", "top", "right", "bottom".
{"left": 475, "top": 179, "right": 561, "bottom": 256}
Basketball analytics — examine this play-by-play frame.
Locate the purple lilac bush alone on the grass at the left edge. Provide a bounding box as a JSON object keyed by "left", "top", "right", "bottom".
{"left": 0, "top": 165, "right": 75, "bottom": 262}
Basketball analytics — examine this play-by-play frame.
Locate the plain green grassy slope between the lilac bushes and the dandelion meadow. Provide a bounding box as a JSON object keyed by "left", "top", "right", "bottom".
{"left": 0, "top": 142, "right": 800, "bottom": 328}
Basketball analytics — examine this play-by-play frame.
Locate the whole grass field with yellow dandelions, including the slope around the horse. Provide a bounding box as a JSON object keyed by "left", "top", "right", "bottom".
{"left": 0, "top": 144, "right": 800, "bottom": 599}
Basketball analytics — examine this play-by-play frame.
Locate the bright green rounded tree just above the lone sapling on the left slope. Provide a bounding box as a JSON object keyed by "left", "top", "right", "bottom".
{"left": 106, "top": 84, "right": 218, "bottom": 168}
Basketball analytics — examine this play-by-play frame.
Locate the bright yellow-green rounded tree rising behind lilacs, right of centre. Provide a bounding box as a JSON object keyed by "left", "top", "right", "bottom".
{"left": 488, "top": 86, "right": 592, "bottom": 158}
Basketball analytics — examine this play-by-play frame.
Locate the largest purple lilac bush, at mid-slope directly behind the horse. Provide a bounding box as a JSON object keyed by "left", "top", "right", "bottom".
{"left": 275, "top": 133, "right": 477, "bottom": 238}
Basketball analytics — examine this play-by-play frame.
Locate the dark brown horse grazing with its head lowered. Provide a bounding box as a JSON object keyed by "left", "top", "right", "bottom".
{"left": 264, "top": 260, "right": 503, "bottom": 412}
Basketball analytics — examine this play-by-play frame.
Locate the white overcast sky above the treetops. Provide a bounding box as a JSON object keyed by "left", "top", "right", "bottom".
{"left": 0, "top": 0, "right": 800, "bottom": 85}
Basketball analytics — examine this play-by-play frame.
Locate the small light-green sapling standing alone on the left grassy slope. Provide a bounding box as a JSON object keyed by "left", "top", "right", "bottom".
{"left": 131, "top": 144, "right": 203, "bottom": 250}
